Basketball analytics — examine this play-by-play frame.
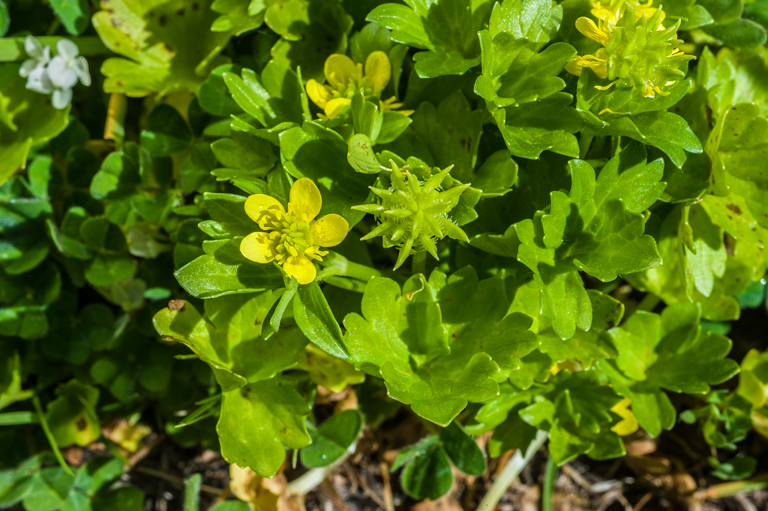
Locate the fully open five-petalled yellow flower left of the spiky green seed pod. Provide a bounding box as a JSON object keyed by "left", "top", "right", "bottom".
{"left": 240, "top": 178, "right": 349, "bottom": 284}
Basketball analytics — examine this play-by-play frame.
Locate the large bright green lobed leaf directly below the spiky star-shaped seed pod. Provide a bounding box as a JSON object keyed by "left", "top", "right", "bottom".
{"left": 344, "top": 267, "right": 538, "bottom": 425}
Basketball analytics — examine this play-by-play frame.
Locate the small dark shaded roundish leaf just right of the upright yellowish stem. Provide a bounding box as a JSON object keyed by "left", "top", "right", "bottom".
{"left": 141, "top": 103, "right": 192, "bottom": 156}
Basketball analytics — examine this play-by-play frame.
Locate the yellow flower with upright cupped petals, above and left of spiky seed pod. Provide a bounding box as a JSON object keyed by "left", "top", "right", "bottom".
{"left": 307, "top": 51, "right": 413, "bottom": 119}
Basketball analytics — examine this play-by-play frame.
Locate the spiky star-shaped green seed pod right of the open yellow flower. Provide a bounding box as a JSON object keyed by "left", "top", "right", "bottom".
{"left": 352, "top": 160, "right": 469, "bottom": 269}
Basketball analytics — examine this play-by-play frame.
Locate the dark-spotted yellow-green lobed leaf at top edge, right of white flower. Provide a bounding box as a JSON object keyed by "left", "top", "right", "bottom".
{"left": 93, "top": 0, "right": 231, "bottom": 97}
